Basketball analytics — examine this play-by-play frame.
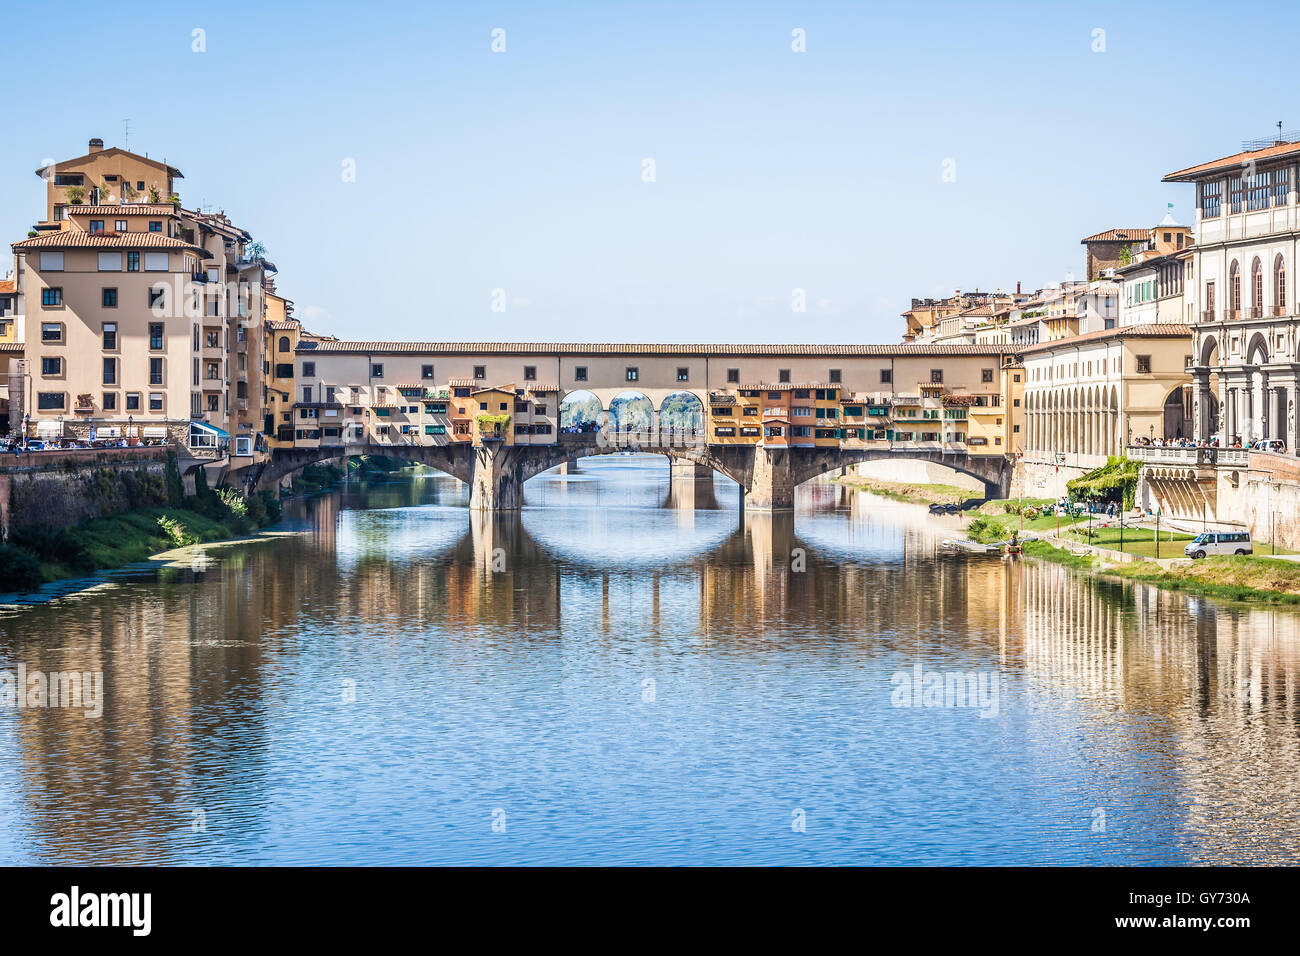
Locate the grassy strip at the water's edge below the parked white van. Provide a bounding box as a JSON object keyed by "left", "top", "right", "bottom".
{"left": 1024, "top": 541, "right": 1300, "bottom": 605}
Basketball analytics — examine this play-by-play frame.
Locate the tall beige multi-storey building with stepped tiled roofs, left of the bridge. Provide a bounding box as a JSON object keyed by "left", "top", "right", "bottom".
{"left": 10, "top": 139, "right": 284, "bottom": 471}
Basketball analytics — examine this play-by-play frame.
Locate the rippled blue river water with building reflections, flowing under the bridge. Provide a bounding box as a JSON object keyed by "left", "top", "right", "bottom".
{"left": 0, "top": 457, "right": 1300, "bottom": 864}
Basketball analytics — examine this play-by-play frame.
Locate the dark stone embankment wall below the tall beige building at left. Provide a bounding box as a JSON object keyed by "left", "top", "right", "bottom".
{"left": 0, "top": 449, "right": 166, "bottom": 537}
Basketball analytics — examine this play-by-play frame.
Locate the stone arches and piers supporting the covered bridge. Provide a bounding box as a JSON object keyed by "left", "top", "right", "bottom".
{"left": 255, "top": 431, "right": 1011, "bottom": 511}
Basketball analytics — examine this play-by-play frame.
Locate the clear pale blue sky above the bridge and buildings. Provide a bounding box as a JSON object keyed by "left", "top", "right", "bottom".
{"left": 0, "top": 0, "right": 1300, "bottom": 342}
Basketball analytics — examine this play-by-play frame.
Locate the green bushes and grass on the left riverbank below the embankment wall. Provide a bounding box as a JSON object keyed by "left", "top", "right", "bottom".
{"left": 0, "top": 486, "right": 282, "bottom": 592}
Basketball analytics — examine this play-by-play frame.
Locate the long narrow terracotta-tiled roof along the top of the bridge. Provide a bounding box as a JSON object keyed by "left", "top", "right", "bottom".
{"left": 298, "top": 341, "right": 1015, "bottom": 358}
